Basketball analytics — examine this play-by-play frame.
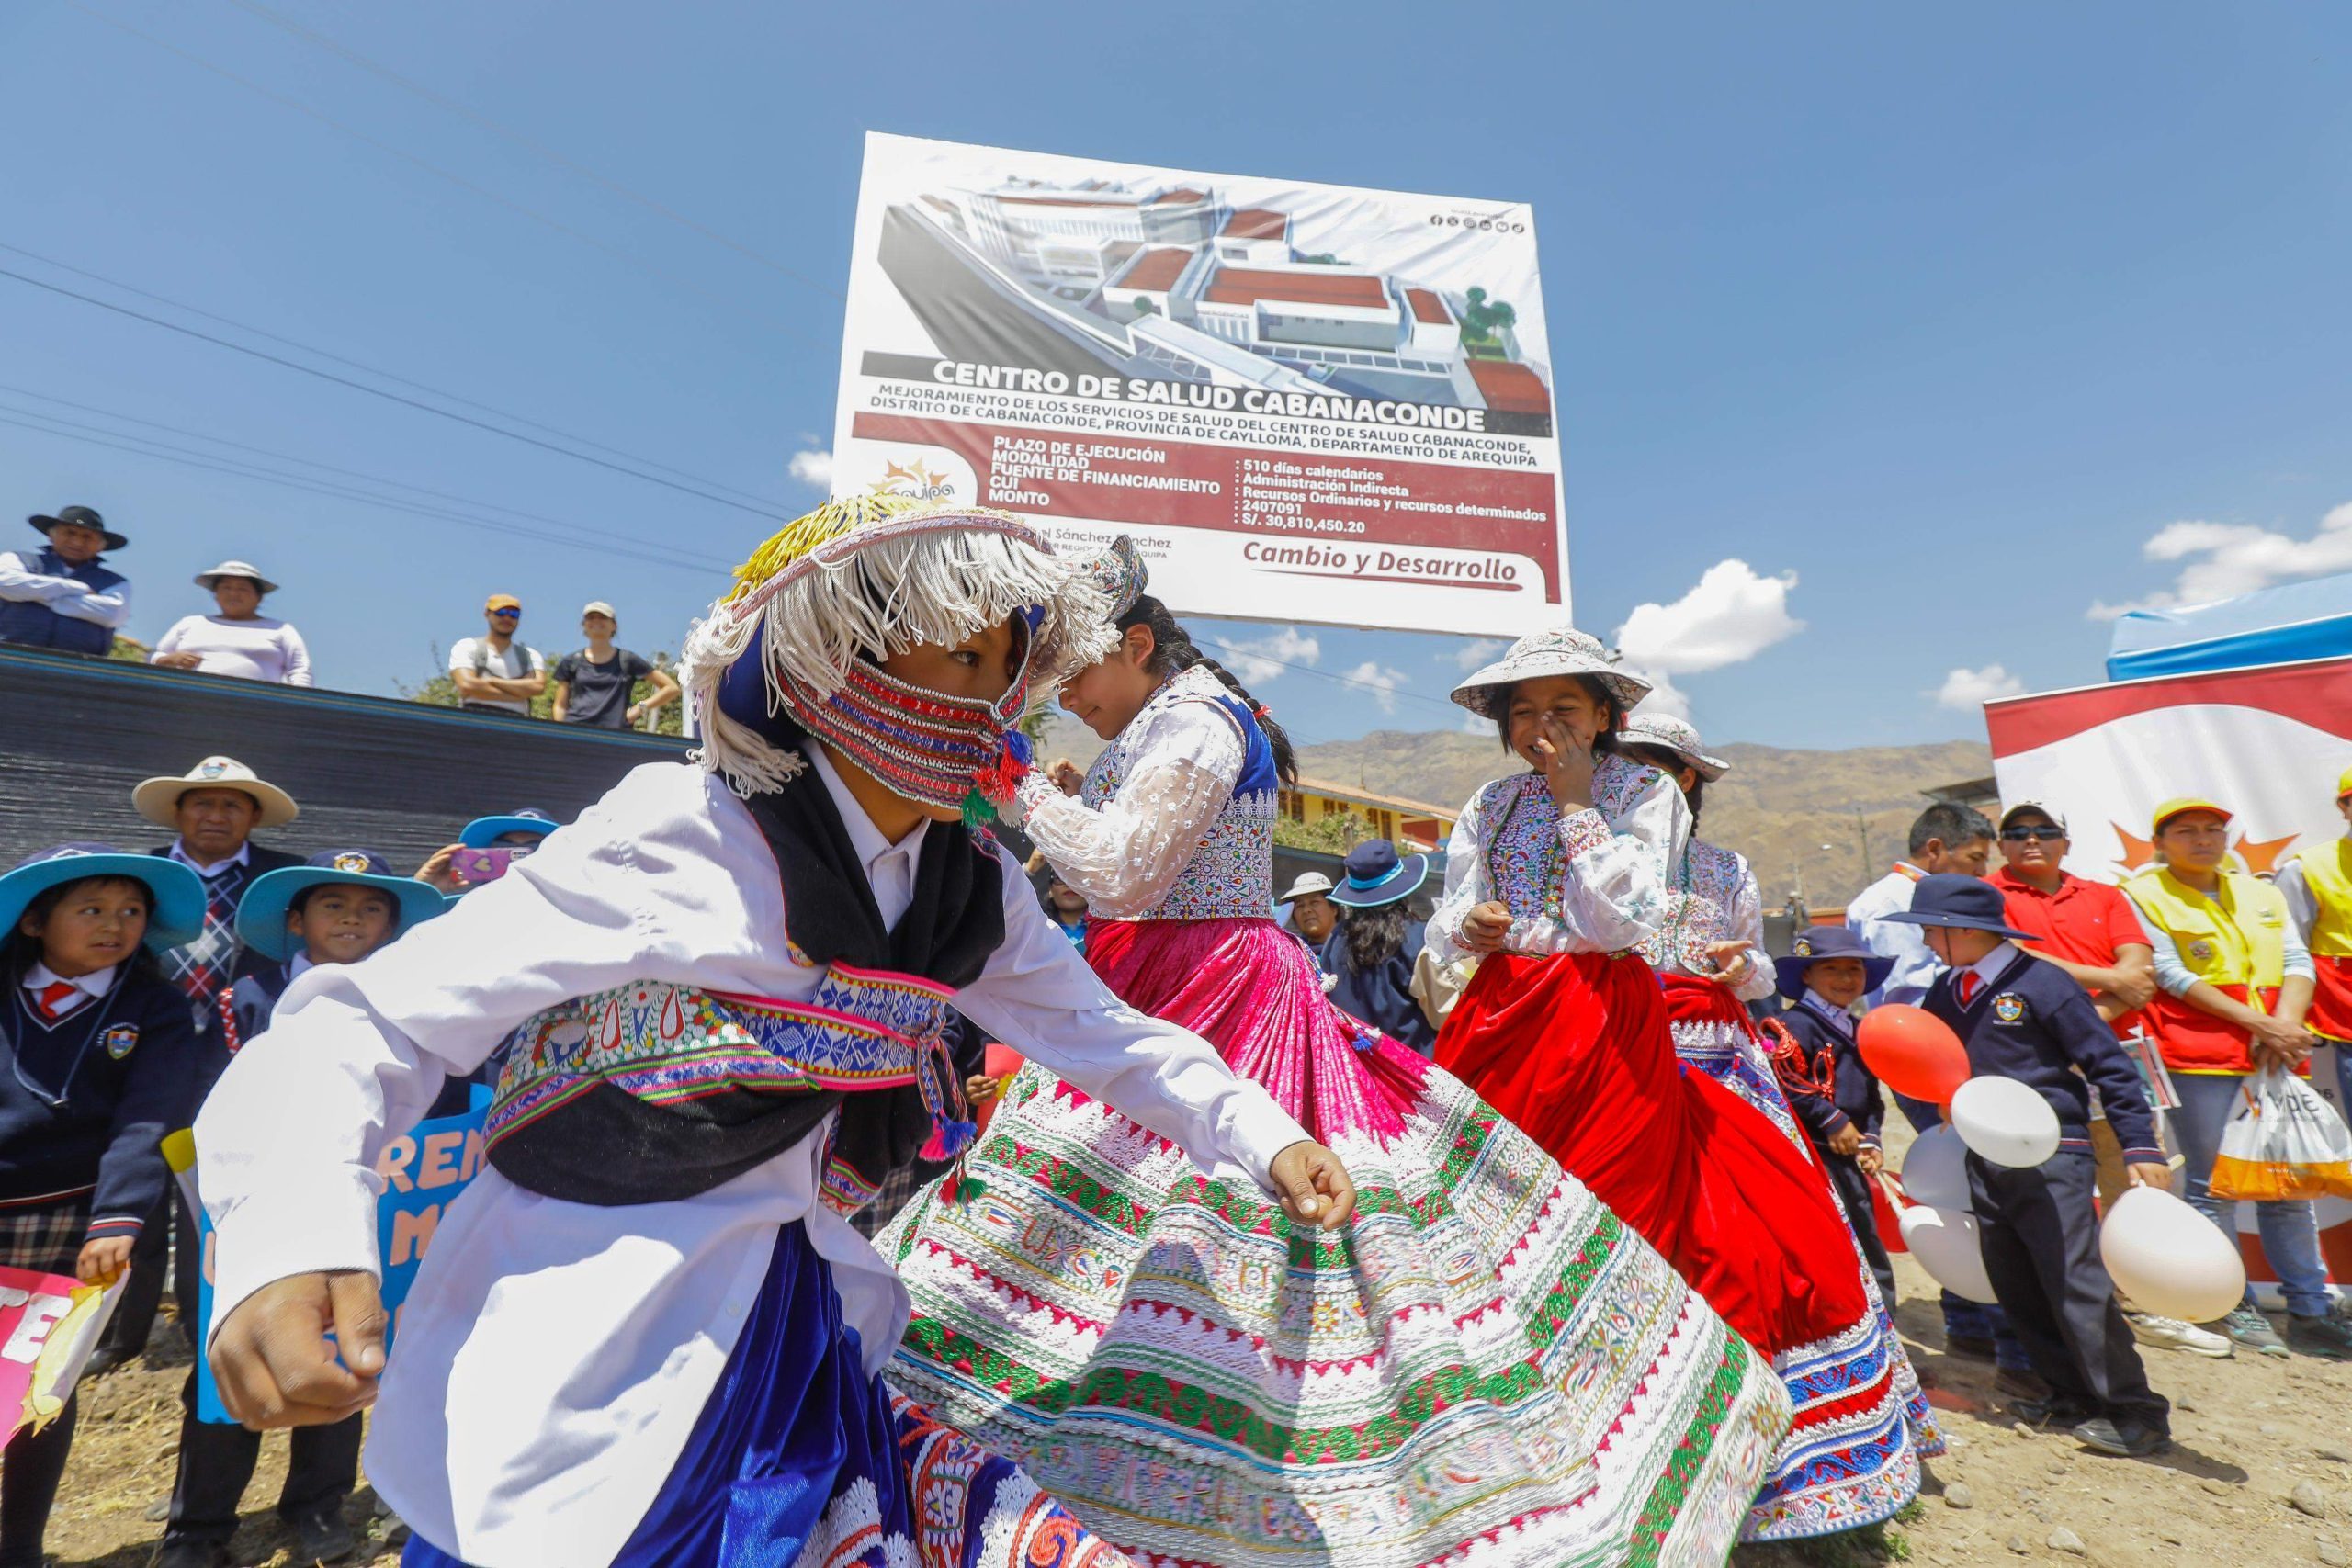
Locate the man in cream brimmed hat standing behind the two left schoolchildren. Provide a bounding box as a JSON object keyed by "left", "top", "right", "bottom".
{"left": 87, "top": 757, "right": 303, "bottom": 1371}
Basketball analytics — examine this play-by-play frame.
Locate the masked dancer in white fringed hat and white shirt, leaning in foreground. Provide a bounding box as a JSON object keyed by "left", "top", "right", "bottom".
{"left": 195, "top": 501, "right": 1355, "bottom": 1568}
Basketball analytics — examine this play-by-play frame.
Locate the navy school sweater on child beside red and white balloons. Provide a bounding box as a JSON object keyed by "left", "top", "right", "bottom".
{"left": 1922, "top": 947, "right": 2164, "bottom": 1164}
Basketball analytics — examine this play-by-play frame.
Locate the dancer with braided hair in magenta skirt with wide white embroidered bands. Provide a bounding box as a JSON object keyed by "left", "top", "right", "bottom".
{"left": 877, "top": 541, "right": 1788, "bottom": 1568}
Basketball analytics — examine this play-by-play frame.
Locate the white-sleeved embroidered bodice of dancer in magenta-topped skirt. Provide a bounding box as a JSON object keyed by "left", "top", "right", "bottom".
{"left": 1021, "top": 668, "right": 1280, "bottom": 919}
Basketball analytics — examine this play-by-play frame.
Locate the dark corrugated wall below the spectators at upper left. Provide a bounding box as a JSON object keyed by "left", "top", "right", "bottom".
{"left": 0, "top": 647, "right": 684, "bottom": 870}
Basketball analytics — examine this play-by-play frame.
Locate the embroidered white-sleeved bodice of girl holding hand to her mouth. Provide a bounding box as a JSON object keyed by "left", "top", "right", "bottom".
{"left": 1430, "top": 755, "right": 1691, "bottom": 959}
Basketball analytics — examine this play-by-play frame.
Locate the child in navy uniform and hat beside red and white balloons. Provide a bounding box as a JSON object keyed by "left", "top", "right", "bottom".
{"left": 1886, "top": 877, "right": 2171, "bottom": 1458}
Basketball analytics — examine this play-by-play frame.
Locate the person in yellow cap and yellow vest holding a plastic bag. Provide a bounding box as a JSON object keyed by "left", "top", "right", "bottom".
{"left": 2124, "top": 797, "right": 2352, "bottom": 1357}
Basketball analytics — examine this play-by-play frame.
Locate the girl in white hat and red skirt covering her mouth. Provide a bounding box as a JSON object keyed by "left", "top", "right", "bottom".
{"left": 1428, "top": 627, "right": 1919, "bottom": 1540}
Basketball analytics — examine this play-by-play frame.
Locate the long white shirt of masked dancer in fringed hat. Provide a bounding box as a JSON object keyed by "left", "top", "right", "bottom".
{"left": 195, "top": 748, "right": 1306, "bottom": 1568}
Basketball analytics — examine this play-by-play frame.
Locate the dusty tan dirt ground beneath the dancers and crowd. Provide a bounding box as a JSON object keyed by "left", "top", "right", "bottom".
{"left": 32, "top": 1194, "right": 2352, "bottom": 1568}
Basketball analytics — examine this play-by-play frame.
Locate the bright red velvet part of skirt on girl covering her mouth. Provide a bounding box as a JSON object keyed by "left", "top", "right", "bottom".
{"left": 1437, "top": 952, "right": 1874, "bottom": 1354}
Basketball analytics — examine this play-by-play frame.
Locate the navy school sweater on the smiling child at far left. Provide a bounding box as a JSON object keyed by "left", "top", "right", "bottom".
{"left": 0, "top": 966, "right": 195, "bottom": 1236}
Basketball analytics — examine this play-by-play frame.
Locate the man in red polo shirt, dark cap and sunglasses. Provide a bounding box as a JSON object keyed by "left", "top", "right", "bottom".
{"left": 1992, "top": 799, "right": 2230, "bottom": 1359}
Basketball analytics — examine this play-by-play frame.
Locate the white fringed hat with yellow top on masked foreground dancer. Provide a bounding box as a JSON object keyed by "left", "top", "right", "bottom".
{"left": 677, "top": 496, "right": 1114, "bottom": 795}
